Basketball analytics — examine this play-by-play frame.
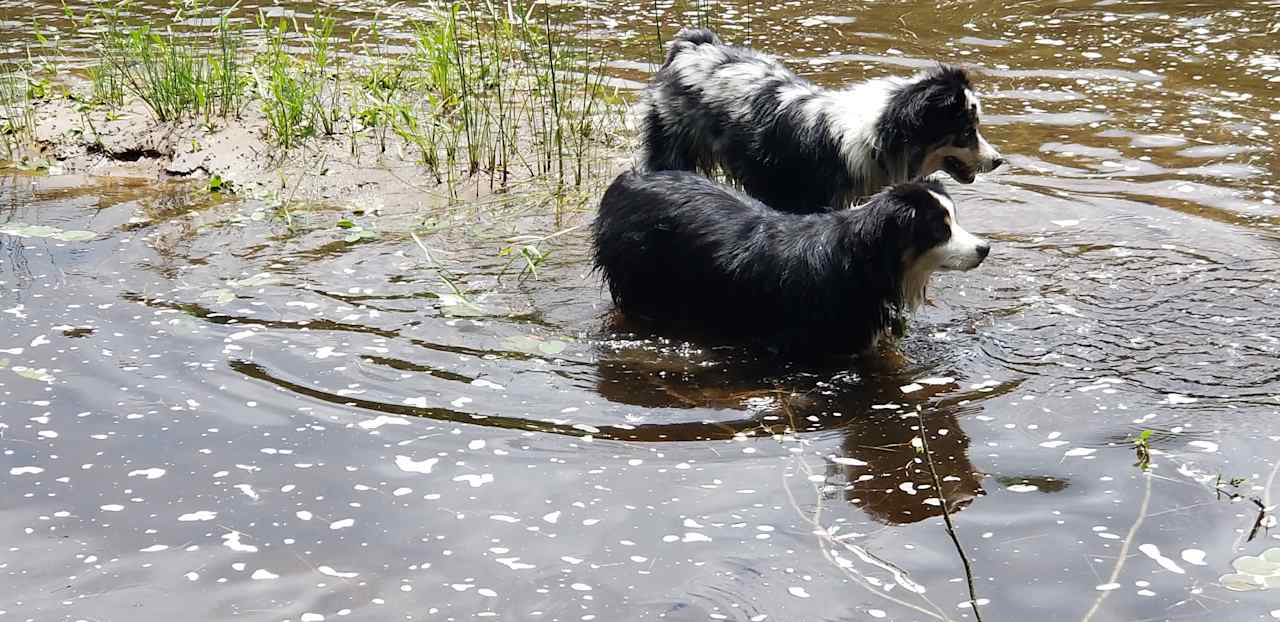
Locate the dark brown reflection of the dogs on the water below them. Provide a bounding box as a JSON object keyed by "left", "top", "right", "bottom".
{"left": 596, "top": 342, "right": 989, "bottom": 523}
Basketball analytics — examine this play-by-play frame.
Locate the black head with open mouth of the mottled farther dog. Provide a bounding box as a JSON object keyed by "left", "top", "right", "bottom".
{"left": 883, "top": 65, "right": 1005, "bottom": 183}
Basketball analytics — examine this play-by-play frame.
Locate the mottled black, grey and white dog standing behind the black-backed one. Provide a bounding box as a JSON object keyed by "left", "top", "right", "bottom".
{"left": 636, "top": 28, "right": 1004, "bottom": 212}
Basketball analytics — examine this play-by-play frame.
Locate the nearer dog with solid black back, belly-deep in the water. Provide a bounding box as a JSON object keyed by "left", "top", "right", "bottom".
{"left": 593, "top": 170, "right": 991, "bottom": 355}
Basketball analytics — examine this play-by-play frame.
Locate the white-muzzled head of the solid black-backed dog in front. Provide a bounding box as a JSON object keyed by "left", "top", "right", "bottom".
{"left": 890, "top": 180, "right": 991, "bottom": 307}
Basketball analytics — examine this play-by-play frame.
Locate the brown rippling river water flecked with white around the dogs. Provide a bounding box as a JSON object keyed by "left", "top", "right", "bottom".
{"left": 0, "top": 0, "right": 1280, "bottom": 622}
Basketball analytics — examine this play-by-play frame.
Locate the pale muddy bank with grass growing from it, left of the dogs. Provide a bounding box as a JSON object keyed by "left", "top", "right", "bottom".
{"left": 19, "top": 77, "right": 634, "bottom": 212}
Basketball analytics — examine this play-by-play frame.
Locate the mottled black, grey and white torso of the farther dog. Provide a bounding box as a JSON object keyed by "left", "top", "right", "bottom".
{"left": 637, "top": 29, "right": 860, "bottom": 214}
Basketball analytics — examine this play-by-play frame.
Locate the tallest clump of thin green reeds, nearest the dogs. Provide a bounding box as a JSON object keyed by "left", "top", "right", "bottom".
{"left": 399, "top": 1, "right": 614, "bottom": 186}
